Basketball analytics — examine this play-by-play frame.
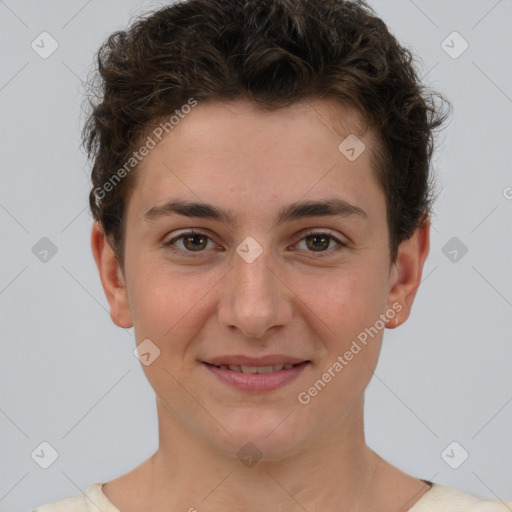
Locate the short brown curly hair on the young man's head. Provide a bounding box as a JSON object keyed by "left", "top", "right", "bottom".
{"left": 82, "top": 0, "right": 451, "bottom": 268}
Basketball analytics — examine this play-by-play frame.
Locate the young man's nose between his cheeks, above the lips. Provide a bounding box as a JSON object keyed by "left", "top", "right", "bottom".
{"left": 218, "top": 244, "right": 293, "bottom": 339}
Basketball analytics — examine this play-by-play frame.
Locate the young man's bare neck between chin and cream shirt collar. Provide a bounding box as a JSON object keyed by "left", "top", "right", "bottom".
{"left": 148, "top": 396, "right": 382, "bottom": 512}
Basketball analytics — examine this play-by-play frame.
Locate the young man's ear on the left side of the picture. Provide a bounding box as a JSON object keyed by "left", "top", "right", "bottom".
{"left": 91, "top": 222, "right": 133, "bottom": 328}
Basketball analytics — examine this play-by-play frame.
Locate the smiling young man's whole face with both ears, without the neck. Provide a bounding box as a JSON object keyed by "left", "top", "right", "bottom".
{"left": 93, "top": 100, "right": 428, "bottom": 459}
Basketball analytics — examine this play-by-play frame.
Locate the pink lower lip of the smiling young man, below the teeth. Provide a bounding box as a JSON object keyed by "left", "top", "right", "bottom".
{"left": 203, "top": 361, "right": 309, "bottom": 393}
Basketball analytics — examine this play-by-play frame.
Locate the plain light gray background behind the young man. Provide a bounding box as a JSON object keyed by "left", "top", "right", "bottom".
{"left": 0, "top": 0, "right": 512, "bottom": 512}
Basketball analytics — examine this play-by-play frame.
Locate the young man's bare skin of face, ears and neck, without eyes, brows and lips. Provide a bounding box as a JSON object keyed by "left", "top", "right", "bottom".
{"left": 91, "top": 99, "right": 429, "bottom": 512}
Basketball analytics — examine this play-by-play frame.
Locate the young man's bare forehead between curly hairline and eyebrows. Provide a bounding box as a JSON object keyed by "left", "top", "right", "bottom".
{"left": 128, "top": 99, "right": 384, "bottom": 220}
